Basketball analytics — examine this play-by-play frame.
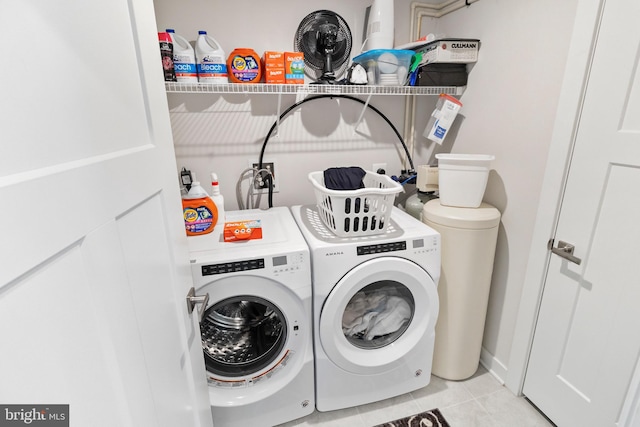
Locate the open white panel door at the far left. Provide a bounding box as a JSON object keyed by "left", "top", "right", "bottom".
{"left": 0, "top": 0, "right": 211, "bottom": 427}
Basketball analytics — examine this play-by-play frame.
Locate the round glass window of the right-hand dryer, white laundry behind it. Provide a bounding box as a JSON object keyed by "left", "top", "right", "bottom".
{"left": 342, "top": 280, "right": 415, "bottom": 349}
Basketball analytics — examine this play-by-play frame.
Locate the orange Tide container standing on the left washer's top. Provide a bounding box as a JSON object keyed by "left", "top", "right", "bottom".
{"left": 182, "top": 175, "right": 219, "bottom": 236}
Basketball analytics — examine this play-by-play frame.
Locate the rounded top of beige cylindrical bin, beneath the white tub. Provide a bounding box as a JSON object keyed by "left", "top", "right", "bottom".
{"left": 422, "top": 199, "right": 500, "bottom": 230}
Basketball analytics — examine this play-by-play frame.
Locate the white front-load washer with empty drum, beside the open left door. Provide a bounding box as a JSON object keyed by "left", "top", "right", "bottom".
{"left": 188, "top": 207, "right": 315, "bottom": 427}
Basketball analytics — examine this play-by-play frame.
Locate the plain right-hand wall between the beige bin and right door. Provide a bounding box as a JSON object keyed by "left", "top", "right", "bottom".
{"left": 423, "top": 0, "right": 577, "bottom": 379}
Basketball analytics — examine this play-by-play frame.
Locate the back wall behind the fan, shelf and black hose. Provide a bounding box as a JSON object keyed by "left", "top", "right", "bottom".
{"left": 155, "top": 0, "right": 416, "bottom": 209}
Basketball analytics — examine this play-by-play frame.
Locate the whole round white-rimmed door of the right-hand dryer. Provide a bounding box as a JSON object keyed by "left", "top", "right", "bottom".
{"left": 319, "top": 257, "right": 438, "bottom": 374}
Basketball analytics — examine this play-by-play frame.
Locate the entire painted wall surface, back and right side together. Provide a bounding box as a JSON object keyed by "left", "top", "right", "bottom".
{"left": 155, "top": 0, "right": 577, "bottom": 384}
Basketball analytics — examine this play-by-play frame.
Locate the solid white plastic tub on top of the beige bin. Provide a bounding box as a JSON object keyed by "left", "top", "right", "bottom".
{"left": 436, "top": 154, "right": 495, "bottom": 208}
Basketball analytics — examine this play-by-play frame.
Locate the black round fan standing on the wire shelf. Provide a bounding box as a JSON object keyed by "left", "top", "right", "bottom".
{"left": 293, "top": 10, "right": 352, "bottom": 79}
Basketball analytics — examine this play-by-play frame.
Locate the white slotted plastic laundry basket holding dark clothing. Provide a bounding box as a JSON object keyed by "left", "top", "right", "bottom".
{"left": 309, "top": 171, "right": 402, "bottom": 237}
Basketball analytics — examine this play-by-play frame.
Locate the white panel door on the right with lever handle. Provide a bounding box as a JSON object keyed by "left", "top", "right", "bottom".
{"left": 523, "top": 0, "right": 640, "bottom": 427}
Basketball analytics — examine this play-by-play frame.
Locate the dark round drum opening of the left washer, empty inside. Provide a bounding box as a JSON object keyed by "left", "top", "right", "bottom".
{"left": 200, "top": 296, "right": 287, "bottom": 377}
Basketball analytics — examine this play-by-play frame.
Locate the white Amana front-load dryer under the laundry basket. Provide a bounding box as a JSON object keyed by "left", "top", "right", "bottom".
{"left": 291, "top": 206, "right": 440, "bottom": 411}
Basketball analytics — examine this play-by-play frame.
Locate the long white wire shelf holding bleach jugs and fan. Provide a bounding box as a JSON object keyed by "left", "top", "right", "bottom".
{"left": 165, "top": 82, "right": 465, "bottom": 96}
